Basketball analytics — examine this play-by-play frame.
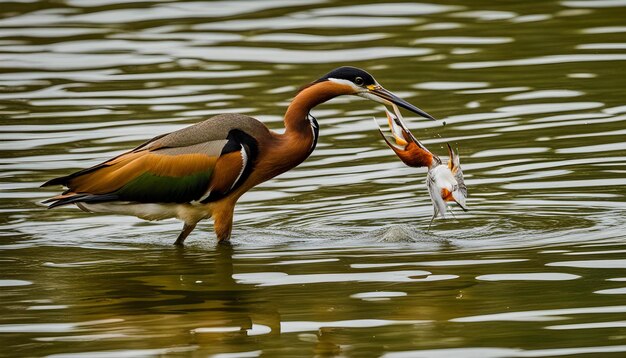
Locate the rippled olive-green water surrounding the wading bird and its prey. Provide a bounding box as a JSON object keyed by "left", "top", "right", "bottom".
{"left": 0, "top": 0, "right": 626, "bottom": 357}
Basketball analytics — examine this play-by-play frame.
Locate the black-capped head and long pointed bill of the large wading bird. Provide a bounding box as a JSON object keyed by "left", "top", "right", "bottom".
{"left": 309, "top": 66, "right": 435, "bottom": 120}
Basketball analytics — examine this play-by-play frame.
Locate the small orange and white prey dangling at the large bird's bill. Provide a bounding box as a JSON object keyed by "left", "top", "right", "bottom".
{"left": 374, "top": 104, "right": 468, "bottom": 229}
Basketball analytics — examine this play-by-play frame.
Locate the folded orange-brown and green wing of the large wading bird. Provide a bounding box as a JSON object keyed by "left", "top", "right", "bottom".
{"left": 44, "top": 125, "right": 257, "bottom": 206}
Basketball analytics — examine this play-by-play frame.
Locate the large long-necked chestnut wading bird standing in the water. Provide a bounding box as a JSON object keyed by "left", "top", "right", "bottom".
{"left": 41, "top": 66, "right": 435, "bottom": 246}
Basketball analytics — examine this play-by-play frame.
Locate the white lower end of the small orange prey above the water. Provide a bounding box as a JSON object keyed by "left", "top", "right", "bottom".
{"left": 426, "top": 144, "right": 468, "bottom": 217}
